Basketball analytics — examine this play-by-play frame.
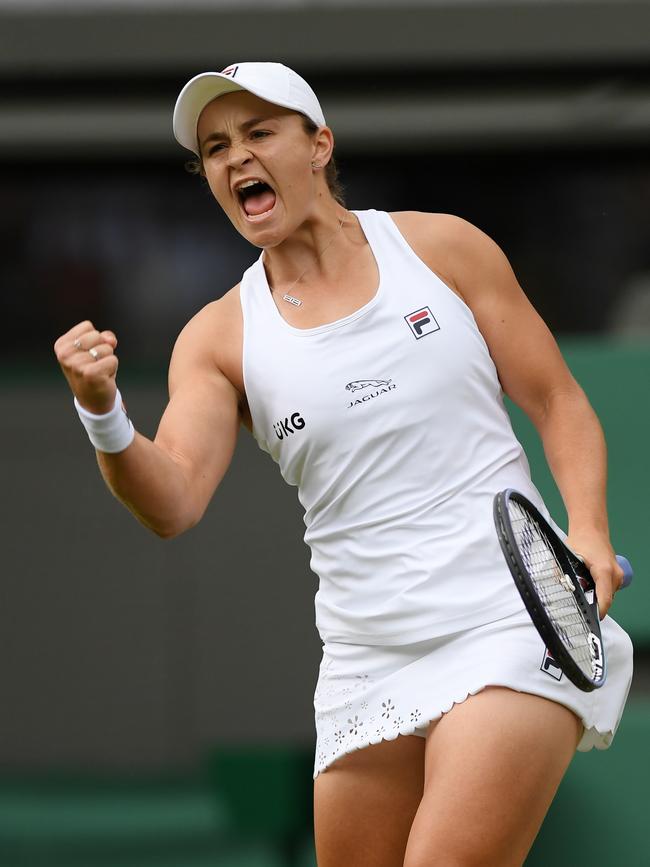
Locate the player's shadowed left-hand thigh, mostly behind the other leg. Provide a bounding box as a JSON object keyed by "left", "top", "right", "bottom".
{"left": 314, "top": 735, "right": 426, "bottom": 867}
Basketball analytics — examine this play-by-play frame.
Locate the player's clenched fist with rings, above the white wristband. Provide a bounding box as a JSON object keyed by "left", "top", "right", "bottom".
{"left": 54, "top": 322, "right": 118, "bottom": 415}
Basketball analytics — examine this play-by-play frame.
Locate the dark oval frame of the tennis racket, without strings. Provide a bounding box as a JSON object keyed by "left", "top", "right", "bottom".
{"left": 493, "top": 488, "right": 607, "bottom": 692}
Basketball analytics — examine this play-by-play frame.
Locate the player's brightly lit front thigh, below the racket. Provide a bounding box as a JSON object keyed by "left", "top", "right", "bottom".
{"left": 404, "top": 687, "right": 582, "bottom": 867}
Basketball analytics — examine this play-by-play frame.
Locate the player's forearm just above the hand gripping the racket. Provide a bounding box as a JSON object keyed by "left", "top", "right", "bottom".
{"left": 536, "top": 385, "right": 609, "bottom": 535}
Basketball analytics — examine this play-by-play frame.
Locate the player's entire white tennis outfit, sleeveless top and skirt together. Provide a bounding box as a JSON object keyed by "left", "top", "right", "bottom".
{"left": 241, "top": 210, "right": 631, "bottom": 776}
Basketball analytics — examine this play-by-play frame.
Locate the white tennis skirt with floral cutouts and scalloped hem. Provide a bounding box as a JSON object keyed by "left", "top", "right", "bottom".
{"left": 314, "top": 608, "right": 632, "bottom": 779}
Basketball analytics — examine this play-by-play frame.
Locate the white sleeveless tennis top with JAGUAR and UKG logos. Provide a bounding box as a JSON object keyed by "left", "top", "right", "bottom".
{"left": 241, "top": 210, "right": 543, "bottom": 644}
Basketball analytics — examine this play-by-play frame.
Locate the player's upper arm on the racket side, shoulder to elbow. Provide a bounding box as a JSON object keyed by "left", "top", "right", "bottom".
{"left": 448, "top": 224, "right": 579, "bottom": 424}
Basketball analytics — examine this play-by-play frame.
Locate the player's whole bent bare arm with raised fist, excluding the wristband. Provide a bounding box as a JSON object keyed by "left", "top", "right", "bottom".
{"left": 55, "top": 302, "right": 239, "bottom": 538}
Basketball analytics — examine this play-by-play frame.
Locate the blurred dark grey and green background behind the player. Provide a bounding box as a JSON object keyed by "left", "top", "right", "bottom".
{"left": 0, "top": 0, "right": 650, "bottom": 867}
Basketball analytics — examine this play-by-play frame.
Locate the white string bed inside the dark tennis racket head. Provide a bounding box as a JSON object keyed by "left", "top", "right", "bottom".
{"left": 508, "top": 500, "right": 595, "bottom": 678}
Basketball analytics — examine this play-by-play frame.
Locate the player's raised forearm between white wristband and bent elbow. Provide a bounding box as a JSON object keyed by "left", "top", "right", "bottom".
{"left": 97, "top": 433, "right": 197, "bottom": 538}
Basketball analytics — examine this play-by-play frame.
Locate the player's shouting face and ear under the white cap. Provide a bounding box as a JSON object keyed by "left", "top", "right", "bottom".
{"left": 197, "top": 91, "right": 331, "bottom": 247}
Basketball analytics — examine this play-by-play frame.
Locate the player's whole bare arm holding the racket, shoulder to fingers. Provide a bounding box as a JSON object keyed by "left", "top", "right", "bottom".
{"left": 400, "top": 215, "right": 623, "bottom": 617}
